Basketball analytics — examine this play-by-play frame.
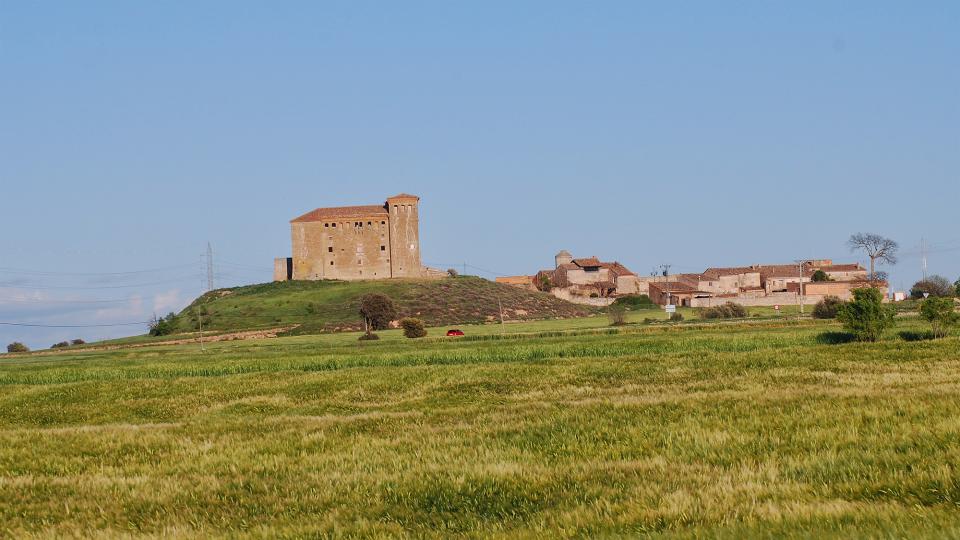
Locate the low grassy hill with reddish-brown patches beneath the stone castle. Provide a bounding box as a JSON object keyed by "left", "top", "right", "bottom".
{"left": 169, "top": 276, "right": 591, "bottom": 334}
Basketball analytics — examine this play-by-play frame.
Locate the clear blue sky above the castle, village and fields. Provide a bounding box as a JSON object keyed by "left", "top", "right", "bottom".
{"left": 0, "top": 1, "right": 960, "bottom": 346}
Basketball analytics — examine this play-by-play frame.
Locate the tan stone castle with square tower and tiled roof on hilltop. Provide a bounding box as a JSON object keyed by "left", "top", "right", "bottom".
{"left": 273, "top": 193, "right": 431, "bottom": 281}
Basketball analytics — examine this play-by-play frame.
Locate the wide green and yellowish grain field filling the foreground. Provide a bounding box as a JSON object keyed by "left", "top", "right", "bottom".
{"left": 0, "top": 313, "right": 960, "bottom": 538}
